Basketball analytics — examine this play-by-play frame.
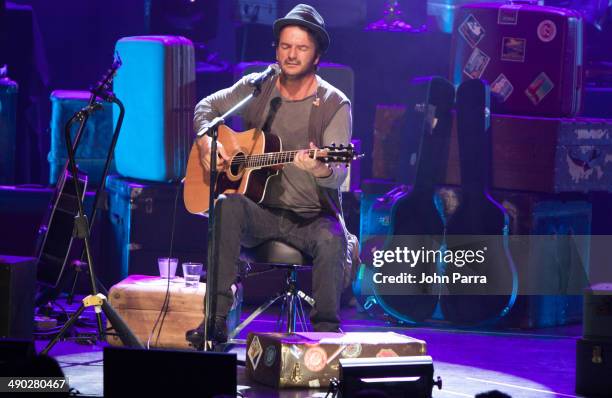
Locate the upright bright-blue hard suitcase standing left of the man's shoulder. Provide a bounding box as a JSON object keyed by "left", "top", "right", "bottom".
{"left": 113, "top": 36, "right": 195, "bottom": 182}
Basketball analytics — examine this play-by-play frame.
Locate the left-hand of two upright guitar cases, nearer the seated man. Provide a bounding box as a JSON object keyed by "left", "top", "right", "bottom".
{"left": 362, "top": 77, "right": 455, "bottom": 323}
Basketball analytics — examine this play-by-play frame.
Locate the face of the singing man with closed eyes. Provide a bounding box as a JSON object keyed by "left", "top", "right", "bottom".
{"left": 276, "top": 26, "right": 319, "bottom": 79}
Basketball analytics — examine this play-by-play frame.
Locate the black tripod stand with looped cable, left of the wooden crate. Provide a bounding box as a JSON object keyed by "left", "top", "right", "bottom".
{"left": 41, "top": 56, "right": 143, "bottom": 354}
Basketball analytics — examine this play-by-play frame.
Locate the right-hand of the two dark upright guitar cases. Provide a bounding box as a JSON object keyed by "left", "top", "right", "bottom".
{"left": 440, "top": 79, "right": 518, "bottom": 325}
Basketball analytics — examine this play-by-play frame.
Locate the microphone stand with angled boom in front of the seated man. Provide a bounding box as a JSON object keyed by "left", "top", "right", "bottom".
{"left": 197, "top": 81, "right": 263, "bottom": 351}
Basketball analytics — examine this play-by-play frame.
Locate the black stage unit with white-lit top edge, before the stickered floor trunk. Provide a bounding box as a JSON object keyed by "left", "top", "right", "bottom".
{"left": 340, "top": 355, "right": 442, "bottom": 398}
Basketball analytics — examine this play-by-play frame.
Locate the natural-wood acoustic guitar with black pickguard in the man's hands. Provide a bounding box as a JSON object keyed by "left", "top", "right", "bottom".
{"left": 183, "top": 125, "right": 361, "bottom": 214}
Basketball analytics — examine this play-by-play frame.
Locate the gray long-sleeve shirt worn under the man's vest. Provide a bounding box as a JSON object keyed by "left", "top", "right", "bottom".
{"left": 194, "top": 77, "right": 352, "bottom": 215}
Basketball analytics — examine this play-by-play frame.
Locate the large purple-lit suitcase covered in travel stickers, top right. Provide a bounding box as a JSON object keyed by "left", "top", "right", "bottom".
{"left": 451, "top": 1, "right": 583, "bottom": 117}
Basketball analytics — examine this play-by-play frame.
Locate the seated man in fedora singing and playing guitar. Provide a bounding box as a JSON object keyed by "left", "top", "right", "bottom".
{"left": 186, "top": 4, "right": 352, "bottom": 346}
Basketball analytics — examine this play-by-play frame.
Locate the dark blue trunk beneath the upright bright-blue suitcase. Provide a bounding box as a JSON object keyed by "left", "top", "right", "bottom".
{"left": 106, "top": 175, "right": 208, "bottom": 281}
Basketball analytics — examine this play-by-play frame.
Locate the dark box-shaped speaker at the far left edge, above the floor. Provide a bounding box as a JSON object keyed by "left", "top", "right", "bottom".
{"left": 0, "top": 255, "right": 36, "bottom": 339}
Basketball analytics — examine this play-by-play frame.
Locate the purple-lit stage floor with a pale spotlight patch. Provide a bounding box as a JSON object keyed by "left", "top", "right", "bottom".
{"left": 36, "top": 296, "right": 581, "bottom": 398}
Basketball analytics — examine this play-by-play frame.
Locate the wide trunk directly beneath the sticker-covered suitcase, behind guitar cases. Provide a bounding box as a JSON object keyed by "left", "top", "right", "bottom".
{"left": 443, "top": 115, "right": 612, "bottom": 194}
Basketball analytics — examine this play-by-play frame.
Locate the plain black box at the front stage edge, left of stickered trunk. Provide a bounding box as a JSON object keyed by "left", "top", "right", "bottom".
{"left": 104, "top": 347, "right": 237, "bottom": 398}
